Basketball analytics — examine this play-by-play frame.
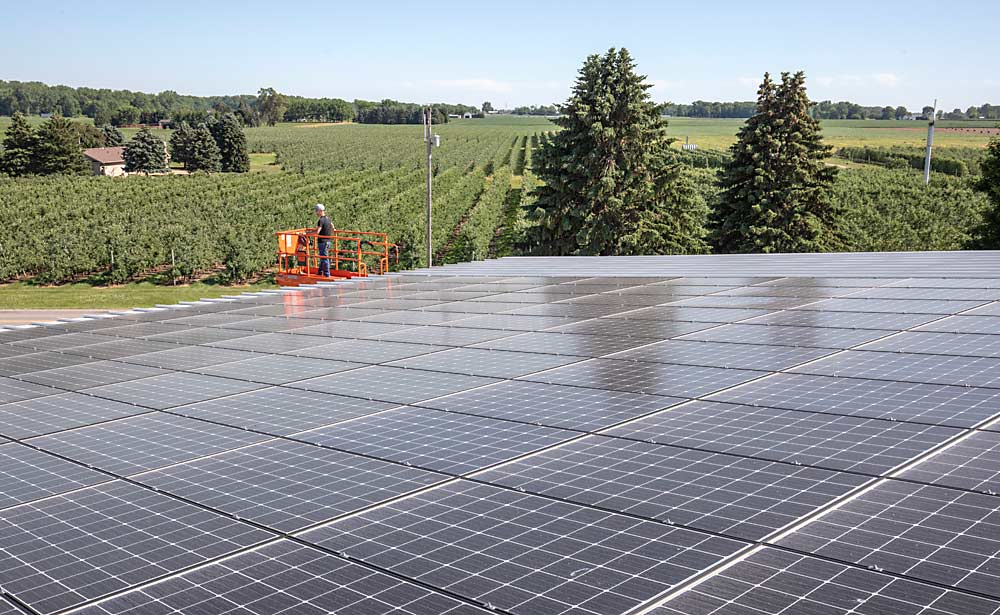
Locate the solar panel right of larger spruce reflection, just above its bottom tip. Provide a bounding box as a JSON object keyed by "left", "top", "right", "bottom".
{"left": 611, "top": 340, "right": 834, "bottom": 371}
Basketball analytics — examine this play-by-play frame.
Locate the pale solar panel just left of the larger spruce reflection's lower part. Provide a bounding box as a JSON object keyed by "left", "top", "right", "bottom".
{"left": 388, "top": 348, "right": 580, "bottom": 378}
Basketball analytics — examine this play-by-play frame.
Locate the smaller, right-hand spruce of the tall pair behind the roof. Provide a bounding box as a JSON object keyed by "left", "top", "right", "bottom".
{"left": 714, "top": 72, "right": 840, "bottom": 252}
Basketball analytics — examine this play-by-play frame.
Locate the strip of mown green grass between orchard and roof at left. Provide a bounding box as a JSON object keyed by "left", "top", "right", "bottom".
{"left": 0, "top": 282, "right": 277, "bottom": 310}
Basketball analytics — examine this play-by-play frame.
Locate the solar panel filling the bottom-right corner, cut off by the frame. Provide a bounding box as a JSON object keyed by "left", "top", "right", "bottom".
{"left": 651, "top": 548, "right": 1000, "bottom": 615}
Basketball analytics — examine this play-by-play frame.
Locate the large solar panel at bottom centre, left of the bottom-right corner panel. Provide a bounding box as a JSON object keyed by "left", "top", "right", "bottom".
{"left": 302, "top": 483, "right": 743, "bottom": 615}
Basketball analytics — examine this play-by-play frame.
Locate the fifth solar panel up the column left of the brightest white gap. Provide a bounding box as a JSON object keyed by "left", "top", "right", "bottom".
{"left": 792, "top": 350, "right": 1000, "bottom": 388}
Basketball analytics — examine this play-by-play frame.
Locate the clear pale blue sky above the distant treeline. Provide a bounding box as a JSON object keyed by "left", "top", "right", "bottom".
{"left": 7, "top": 0, "right": 1000, "bottom": 110}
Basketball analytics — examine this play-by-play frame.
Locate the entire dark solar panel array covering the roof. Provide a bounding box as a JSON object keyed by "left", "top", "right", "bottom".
{"left": 0, "top": 270, "right": 1000, "bottom": 615}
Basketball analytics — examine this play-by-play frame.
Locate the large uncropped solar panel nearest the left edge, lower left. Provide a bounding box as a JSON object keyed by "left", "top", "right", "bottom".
{"left": 28, "top": 412, "right": 268, "bottom": 476}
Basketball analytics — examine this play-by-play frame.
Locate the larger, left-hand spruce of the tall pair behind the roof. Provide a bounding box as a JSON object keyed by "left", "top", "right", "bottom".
{"left": 524, "top": 49, "right": 707, "bottom": 255}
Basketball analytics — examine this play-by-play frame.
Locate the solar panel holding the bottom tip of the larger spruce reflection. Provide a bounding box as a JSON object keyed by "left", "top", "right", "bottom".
{"left": 521, "top": 359, "right": 767, "bottom": 397}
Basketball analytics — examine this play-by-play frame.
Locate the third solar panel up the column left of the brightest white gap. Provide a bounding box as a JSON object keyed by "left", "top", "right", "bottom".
{"left": 607, "top": 402, "right": 959, "bottom": 474}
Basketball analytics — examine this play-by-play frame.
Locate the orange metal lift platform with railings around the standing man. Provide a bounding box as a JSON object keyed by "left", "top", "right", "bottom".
{"left": 275, "top": 228, "right": 399, "bottom": 286}
